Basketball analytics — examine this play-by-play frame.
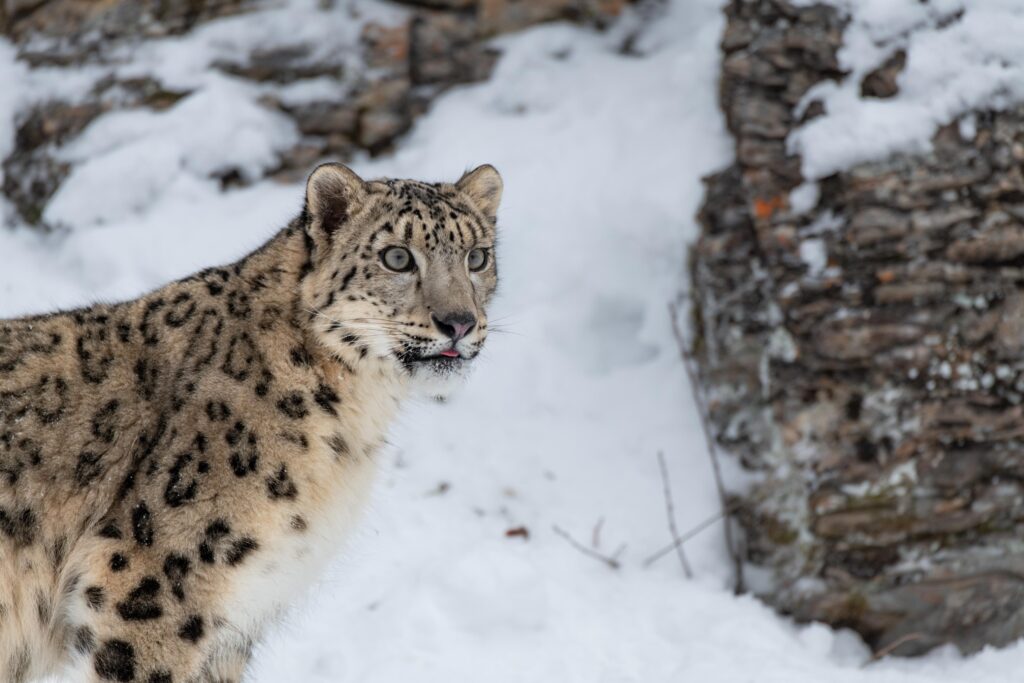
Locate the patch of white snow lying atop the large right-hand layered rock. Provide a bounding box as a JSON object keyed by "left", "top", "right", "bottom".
{"left": 788, "top": 0, "right": 1024, "bottom": 179}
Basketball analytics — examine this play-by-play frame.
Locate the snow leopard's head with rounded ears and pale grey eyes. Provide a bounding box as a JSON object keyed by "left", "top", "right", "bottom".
{"left": 303, "top": 164, "right": 502, "bottom": 395}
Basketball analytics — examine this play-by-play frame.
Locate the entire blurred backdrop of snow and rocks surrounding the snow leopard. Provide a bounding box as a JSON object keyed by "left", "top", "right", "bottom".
{"left": 6, "top": 0, "right": 1024, "bottom": 683}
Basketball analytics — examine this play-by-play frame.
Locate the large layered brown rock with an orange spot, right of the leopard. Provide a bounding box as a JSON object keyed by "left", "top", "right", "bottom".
{"left": 691, "top": 0, "right": 1024, "bottom": 654}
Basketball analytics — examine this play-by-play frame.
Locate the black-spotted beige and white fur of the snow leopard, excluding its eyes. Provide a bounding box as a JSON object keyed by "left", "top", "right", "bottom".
{"left": 0, "top": 165, "right": 502, "bottom": 683}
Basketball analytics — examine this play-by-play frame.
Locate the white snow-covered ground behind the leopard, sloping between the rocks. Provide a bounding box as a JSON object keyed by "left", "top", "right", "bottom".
{"left": 6, "top": 0, "right": 1024, "bottom": 683}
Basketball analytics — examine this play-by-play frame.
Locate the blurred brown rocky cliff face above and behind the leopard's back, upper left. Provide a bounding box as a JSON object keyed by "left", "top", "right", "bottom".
{"left": 0, "top": 0, "right": 626, "bottom": 228}
